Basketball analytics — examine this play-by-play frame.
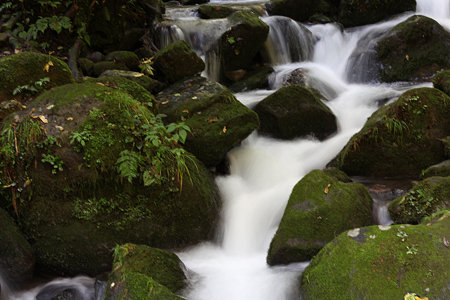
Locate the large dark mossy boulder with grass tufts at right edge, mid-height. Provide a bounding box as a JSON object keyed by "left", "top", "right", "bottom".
{"left": 330, "top": 88, "right": 450, "bottom": 177}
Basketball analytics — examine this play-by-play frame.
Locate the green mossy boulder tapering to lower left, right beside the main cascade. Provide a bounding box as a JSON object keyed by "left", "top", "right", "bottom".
{"left": 267, "top": 170, "right": 373, "bottom": 265}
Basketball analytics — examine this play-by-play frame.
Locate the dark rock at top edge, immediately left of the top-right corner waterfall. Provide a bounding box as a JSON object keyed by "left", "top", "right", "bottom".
{"left": 339, "top": 0, "right": 416, "bottom": 27}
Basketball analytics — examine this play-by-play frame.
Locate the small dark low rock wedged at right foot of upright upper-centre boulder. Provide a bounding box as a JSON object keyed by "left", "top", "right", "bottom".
{"left": 229, "top": 66, "right": 274, "bottom": 93}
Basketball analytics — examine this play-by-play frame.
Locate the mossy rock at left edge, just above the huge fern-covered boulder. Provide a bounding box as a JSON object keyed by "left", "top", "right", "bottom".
{"left": 0, "top": 52, "right": 73, "bottom": 102}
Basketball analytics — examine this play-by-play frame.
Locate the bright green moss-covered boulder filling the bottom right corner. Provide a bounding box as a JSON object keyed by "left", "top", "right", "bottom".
{"left": 299, "top": 219, "right": 450, "bottom": 300}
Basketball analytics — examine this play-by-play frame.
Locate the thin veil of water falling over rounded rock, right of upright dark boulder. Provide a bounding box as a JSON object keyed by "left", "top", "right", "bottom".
{"left": 262, "top": 16, "right": 315, "bottom": 65}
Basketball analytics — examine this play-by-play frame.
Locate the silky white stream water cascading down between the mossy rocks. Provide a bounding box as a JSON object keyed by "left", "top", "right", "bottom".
{"left": 2, "top": 0, "right": 450, "bottom": 300}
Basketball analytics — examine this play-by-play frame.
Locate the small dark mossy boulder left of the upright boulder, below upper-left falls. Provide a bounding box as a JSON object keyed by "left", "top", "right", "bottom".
{"left": 153, "top": 40, "right": 205, "bottom": 83}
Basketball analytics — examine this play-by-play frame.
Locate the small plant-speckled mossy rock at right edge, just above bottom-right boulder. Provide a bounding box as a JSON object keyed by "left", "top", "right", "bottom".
{"left": 389, "top": 177, "right": 450, "bottom": 224}
